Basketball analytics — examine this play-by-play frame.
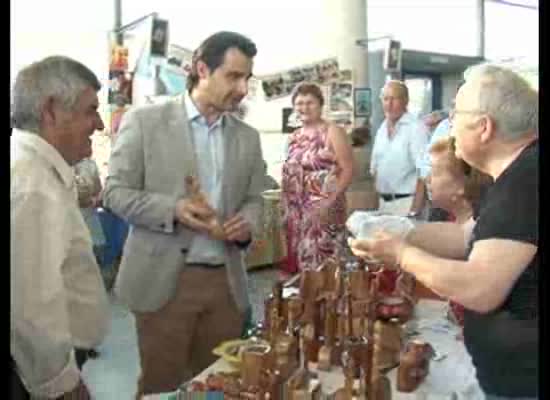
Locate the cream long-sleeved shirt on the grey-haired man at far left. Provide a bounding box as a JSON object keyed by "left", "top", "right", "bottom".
{"left": 10, "top": 129, "right": 110, "bottom": 398}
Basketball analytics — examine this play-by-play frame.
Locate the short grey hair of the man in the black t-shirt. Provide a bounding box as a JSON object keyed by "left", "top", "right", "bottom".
{"left": 464, "top": 64, "right": 539, "bottom": 140}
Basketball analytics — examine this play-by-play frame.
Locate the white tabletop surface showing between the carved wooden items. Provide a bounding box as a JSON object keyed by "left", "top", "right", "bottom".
{"left": 145, "top": 299, "right": 484, "bottom": 400}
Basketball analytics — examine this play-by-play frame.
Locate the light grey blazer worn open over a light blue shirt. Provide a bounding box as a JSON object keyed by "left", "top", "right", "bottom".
{"left": 103, "top": 96, "right": 264, "bottom": 312}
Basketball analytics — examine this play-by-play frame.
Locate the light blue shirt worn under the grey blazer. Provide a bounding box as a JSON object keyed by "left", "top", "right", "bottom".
{"left": 184, "top": 93, "right": 229, "bottom": 264}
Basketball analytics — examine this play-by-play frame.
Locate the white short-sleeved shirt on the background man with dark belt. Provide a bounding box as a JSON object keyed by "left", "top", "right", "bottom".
{"left": 370, "top": 112, "right": 428, "bottom": 194}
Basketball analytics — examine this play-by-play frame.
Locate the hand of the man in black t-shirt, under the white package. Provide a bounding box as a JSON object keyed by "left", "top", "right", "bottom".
{"left": 349, "top": 232, "right": 407, "bottom": 266}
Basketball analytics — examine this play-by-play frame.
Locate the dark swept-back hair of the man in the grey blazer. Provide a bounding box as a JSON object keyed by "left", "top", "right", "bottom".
{"left": 187, "top": 31, "right": 258, "bottom": 90}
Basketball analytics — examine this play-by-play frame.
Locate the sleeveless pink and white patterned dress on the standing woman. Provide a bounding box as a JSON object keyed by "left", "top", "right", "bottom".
{"left": 281, "top": 124, "right": 346, "bottom": 273}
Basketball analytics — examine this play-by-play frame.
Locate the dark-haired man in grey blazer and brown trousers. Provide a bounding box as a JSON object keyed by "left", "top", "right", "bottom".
{"left": 103, "top": 32, "right": 264, "bottom": 398}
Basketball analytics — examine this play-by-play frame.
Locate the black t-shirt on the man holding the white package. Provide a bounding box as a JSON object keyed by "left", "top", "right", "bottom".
{"left": 464, "top": 142, "right": 539, "bottom": 397}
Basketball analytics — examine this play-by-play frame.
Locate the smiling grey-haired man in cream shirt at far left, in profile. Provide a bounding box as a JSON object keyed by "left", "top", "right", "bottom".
{"left": 10, "top": 56, "right": 110, "bottom": 399}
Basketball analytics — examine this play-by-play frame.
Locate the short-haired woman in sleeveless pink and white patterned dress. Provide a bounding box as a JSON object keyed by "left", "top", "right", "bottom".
{"left": 281, "top": 83, "right": 353, "bottom": 274}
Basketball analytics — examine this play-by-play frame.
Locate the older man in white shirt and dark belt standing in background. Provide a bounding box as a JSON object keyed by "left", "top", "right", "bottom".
{"left": 370, "top": 80, "right": 428, "bottom": 215}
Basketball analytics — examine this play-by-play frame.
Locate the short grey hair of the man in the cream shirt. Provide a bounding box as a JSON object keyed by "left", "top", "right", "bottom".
{"left": 11, "top": 56, "right": 101, "bottom": 134}
